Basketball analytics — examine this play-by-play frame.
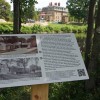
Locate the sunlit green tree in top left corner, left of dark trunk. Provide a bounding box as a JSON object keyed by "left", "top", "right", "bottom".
{"left": 0, "top": 0, "right": 10, "bottom": 21}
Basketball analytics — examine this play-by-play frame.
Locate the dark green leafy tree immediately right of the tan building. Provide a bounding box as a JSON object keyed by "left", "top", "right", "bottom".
{"left": 66, "top": 0, "right": 89, "bottom": 21}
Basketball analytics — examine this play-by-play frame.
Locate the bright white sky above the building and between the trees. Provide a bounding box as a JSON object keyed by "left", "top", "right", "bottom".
{"left": 6, "top": 0, "right": 67, "bottom": 10}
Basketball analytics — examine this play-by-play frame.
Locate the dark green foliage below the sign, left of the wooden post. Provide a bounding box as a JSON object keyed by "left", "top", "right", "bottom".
{"left": 0, "top": 86, "right": 31, "bottom": 100}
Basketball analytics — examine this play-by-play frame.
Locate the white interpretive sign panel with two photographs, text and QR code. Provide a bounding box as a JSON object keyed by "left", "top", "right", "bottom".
{"left": 0, "top": 33, "right": 89, "bottom": 88}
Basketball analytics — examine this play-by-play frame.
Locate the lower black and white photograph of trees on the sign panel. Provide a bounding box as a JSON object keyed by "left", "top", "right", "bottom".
{"left": 0, "top": 57, "right": 42, "bottom": 80}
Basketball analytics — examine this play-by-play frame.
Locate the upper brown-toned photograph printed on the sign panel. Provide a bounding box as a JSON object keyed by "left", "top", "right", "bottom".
{"left": 0, "top": 35, "right": 38, "bottom": 55}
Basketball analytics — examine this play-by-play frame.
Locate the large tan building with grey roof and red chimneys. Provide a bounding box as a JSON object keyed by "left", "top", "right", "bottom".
{"left": 40, "top": 2, "right": 68, "bottom": 23}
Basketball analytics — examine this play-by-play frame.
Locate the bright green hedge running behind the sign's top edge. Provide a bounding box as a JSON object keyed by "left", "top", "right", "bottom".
{"left": 0, "top": 23, "right": 87, "bottom": 34}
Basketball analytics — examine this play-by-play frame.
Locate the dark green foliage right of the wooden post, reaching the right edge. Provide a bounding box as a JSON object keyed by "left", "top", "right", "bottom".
{"left": 49, "top": 81, "right": 100, "bottom": 100}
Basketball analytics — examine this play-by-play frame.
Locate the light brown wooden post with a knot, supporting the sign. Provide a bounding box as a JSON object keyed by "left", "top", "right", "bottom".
{"left": 31, "top": 84, "right": 49, "bottom": 100}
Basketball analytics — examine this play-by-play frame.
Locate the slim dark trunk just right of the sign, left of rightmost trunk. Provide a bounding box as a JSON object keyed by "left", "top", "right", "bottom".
{"left": 85, "top": 0, "right": 96, "bottom": 69}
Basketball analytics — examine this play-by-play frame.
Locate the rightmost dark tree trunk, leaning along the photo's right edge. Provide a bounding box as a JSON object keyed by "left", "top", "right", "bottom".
{"left": 86, "top": 0, "right": 100, "bottom": 90}
